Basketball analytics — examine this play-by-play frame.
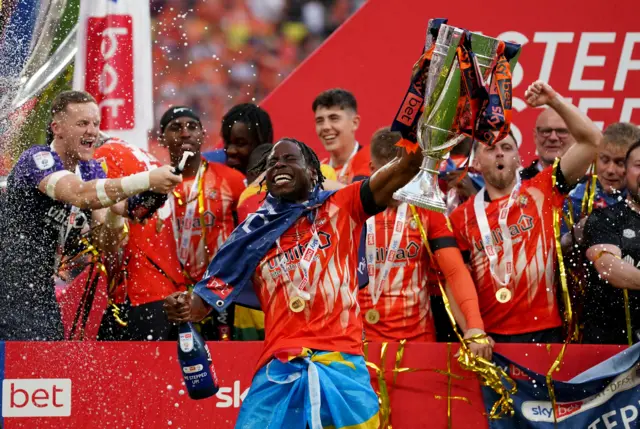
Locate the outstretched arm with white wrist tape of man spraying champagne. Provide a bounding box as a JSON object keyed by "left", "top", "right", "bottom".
{"left": 38, "top": 166, "right": 182, "bottom": 209}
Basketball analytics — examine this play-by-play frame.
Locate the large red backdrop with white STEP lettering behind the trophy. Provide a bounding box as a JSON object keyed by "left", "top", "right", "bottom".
{"left": 262, "top": 0, "right": 640, "bottom": 162}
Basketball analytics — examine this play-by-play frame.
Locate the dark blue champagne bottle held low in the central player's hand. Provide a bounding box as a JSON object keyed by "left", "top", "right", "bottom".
{"left": 178, "top": 322, "right": 220, "bottom": 399}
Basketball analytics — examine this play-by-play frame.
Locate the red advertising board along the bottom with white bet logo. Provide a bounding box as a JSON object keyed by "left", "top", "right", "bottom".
{"left": 2, "top": 342, "right": 622, "bottom": 429}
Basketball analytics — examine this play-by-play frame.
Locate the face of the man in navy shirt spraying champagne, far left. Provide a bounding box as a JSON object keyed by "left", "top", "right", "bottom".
{"left": 51, "top": 103, "right": 100, "bottom": 161}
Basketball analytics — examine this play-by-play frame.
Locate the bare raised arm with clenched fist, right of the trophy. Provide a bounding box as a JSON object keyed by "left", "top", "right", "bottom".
{"left": 525, "top": 81, "right": 602, "bottom": 185}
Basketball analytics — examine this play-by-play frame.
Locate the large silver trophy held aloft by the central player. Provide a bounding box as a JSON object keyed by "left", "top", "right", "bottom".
{"left": 393, "top": 24, "right": 518, "bottom": 213}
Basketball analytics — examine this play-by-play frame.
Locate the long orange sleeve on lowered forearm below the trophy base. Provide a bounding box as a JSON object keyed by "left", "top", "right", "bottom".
{"left": 434, "top": 247, "right": 484, "bottom": 330}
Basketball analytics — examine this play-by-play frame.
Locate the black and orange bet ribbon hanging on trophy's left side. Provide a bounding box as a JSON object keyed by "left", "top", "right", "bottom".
{"left": 391, "top": 19, "right": 447, "bottom": 153}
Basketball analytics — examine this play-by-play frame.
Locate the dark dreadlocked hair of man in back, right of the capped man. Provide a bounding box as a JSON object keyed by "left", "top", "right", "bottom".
{"left": 220, "top": 103, "right": 273, "bottom": 146}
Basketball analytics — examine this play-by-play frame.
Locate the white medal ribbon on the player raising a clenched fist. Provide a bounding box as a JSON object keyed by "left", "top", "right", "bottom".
{"left": 473, "top": 174, "right": 521, "bottom": 286}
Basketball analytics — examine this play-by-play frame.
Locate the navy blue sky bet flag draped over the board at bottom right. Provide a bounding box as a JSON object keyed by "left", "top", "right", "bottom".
{"left": 482, "top": 343, "right": 640, "bottom": 429}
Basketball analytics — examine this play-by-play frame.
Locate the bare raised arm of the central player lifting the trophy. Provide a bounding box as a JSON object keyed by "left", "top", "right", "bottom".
{"left": 369, "top": 147, "right": 422, "bottom": 207}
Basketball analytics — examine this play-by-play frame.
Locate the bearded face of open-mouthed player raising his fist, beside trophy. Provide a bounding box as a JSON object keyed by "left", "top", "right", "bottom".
{"left": 476, "top": 137, "right": 520, "bottom": 189}
